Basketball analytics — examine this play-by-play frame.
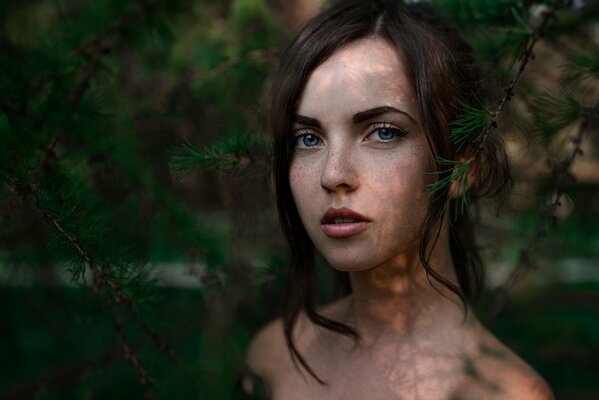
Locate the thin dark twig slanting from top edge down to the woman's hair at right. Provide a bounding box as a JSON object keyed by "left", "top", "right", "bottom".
{"left": 468, "top": 0, "right": 560, "bottom": 163}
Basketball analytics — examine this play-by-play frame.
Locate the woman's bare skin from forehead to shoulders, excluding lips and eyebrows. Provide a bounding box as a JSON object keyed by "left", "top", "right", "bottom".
{"left": 248, "top": 38, "right": 553, "bottom": 400}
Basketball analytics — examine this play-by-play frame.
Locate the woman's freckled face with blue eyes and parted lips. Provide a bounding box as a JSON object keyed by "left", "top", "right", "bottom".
{"left": 289, "top": 38, "right": 431, "bottom": 271}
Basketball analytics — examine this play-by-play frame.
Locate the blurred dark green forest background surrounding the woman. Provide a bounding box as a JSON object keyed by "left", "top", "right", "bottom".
{"left": 0, "top": 0, "right": 599, "bottom": 399}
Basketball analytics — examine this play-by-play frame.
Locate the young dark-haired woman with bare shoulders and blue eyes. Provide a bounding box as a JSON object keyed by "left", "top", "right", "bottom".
{"left": 246, "top": 0, "right": 553, "bottom": 400}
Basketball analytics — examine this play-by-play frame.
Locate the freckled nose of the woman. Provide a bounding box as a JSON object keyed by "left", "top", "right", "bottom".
{"left": 320, "top": 149, "right": 359, "bottom": 192}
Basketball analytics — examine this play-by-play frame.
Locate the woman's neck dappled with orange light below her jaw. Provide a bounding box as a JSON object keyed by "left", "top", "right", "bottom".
{"left": 346, "top": 227, "right": 472, "bottom": 344}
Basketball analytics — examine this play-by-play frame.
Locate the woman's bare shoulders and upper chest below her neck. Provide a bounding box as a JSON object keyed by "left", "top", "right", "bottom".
{"left": 248, "top": 298, "right": 554, "bottom": 400}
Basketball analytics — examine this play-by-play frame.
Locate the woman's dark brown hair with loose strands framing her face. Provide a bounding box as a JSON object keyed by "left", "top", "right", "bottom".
{"left": 269, "top": 0, "right": 511, "bottom": 384}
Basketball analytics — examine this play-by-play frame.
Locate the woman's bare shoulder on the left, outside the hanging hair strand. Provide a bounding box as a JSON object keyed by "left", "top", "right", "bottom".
{"left": 246, "top": 318, "right": 292, "bottom": 382}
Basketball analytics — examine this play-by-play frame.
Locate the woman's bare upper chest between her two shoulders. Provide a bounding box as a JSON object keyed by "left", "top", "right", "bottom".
{"left": 272, "top": 347, "right": 465, "bottom": 400}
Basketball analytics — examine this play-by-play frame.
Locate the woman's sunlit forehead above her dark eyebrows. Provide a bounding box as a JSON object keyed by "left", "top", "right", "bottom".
{"left": 297, "top": 38, "right": 417, "bottom": 118}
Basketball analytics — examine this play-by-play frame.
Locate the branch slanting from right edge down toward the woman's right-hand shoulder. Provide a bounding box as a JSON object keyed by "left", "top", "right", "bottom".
{"left": 486, "top": 101, "right": 599, "bottom": 326}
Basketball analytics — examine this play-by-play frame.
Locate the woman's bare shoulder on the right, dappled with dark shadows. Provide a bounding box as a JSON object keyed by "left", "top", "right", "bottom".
{"left": 458, "top": 324, "right": 555, "bottom": 400}
